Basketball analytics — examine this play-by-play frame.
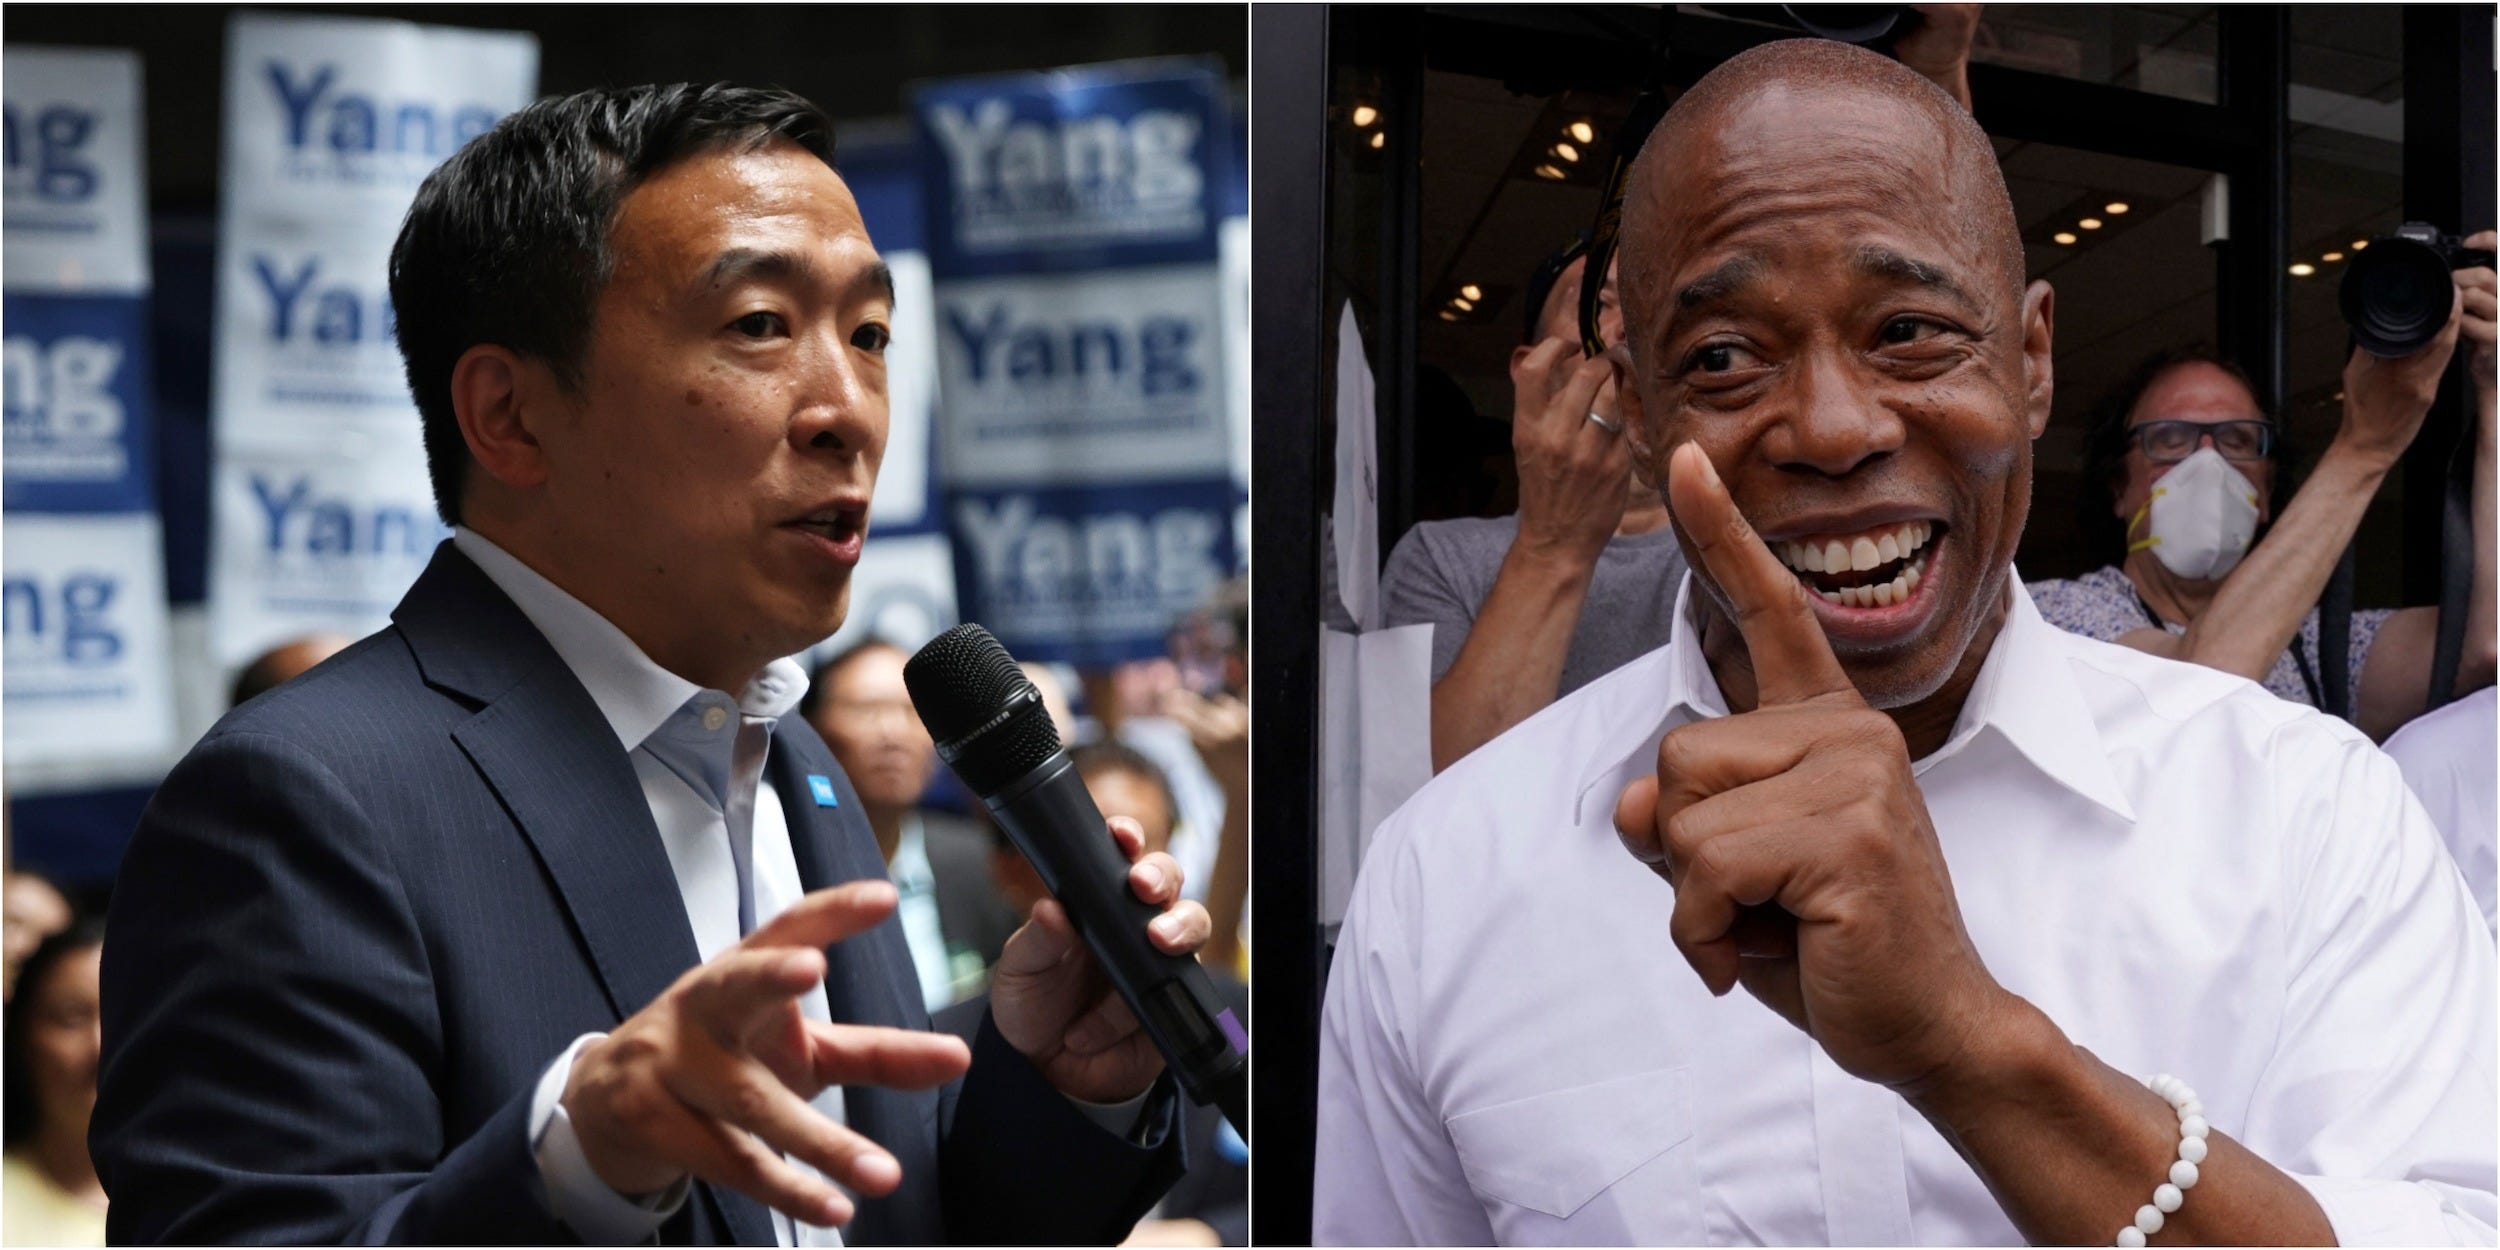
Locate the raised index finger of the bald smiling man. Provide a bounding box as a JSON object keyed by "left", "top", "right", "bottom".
{"left": 1668, "top": 443, "right": 1858, "bottom": 708}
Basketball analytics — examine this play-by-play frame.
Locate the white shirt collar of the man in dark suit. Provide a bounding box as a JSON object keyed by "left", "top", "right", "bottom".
{"left": 453, "top": 528, "right": 808, "bottom": 750}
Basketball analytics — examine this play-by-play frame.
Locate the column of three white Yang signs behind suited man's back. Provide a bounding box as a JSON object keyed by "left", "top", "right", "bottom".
{"left": 210, "top": 13, "right": 538, "bottom": 665}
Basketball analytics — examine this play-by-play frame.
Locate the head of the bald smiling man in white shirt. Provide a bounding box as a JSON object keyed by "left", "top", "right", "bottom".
{"left": 1623, "top": 45, "right": 2050, "bottom": 708}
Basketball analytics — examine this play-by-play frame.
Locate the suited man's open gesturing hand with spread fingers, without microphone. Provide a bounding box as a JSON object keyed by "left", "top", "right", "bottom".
{"left": 563, "top": 880, "right": 973, "bottom": 1225}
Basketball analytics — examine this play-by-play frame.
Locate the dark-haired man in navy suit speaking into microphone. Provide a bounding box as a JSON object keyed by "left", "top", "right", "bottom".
{"left": 90, "top": 85, "right": 1208, "bottom": 1245}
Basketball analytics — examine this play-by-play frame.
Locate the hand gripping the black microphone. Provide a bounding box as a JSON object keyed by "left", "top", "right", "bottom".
{"left": 990, "top": 815, "right": 1213, "bottom": 1103}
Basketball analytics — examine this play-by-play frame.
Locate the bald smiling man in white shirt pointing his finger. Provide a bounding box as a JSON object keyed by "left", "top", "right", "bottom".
{"left": 1315, "top": 40, "right": 2495, "bottom": 1245}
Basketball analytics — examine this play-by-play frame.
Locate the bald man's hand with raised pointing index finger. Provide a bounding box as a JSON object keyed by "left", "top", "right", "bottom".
{"left": 1615, "top": 445, "right": 2020, "bottom": 1095}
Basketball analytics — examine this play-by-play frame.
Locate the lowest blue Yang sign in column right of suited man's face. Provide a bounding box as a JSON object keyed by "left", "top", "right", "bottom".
{"left": 948, "top": 470, "right": 1235, "bottom": 668}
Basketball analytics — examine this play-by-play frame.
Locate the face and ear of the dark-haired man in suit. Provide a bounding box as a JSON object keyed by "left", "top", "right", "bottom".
{"left": 492, "top": 143, "right": 893, "bottom": 690}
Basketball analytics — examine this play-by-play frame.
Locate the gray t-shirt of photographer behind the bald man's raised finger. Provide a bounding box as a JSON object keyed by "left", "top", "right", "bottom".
{"left": 1380, "top": 515, "right": 1685, "bottom": 698}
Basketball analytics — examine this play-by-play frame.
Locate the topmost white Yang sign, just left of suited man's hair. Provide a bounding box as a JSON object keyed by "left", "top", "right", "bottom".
{"left": 223, "top": 13, "right": 538, "bottom": 223}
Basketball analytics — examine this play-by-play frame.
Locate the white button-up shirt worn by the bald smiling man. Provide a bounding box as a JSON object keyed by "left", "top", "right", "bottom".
{"left": 1313, "top": 578, "right": 2500, "bottom": 1245}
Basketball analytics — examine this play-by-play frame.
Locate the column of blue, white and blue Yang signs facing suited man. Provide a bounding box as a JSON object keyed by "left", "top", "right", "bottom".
{"left": 915, "top": 63, "right": 1238, "bottom": 665}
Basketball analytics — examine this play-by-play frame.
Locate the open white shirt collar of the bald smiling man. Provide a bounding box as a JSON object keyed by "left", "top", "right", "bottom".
{"left": 1573, "top": 570, "right": 2135, "bottom": 823}
